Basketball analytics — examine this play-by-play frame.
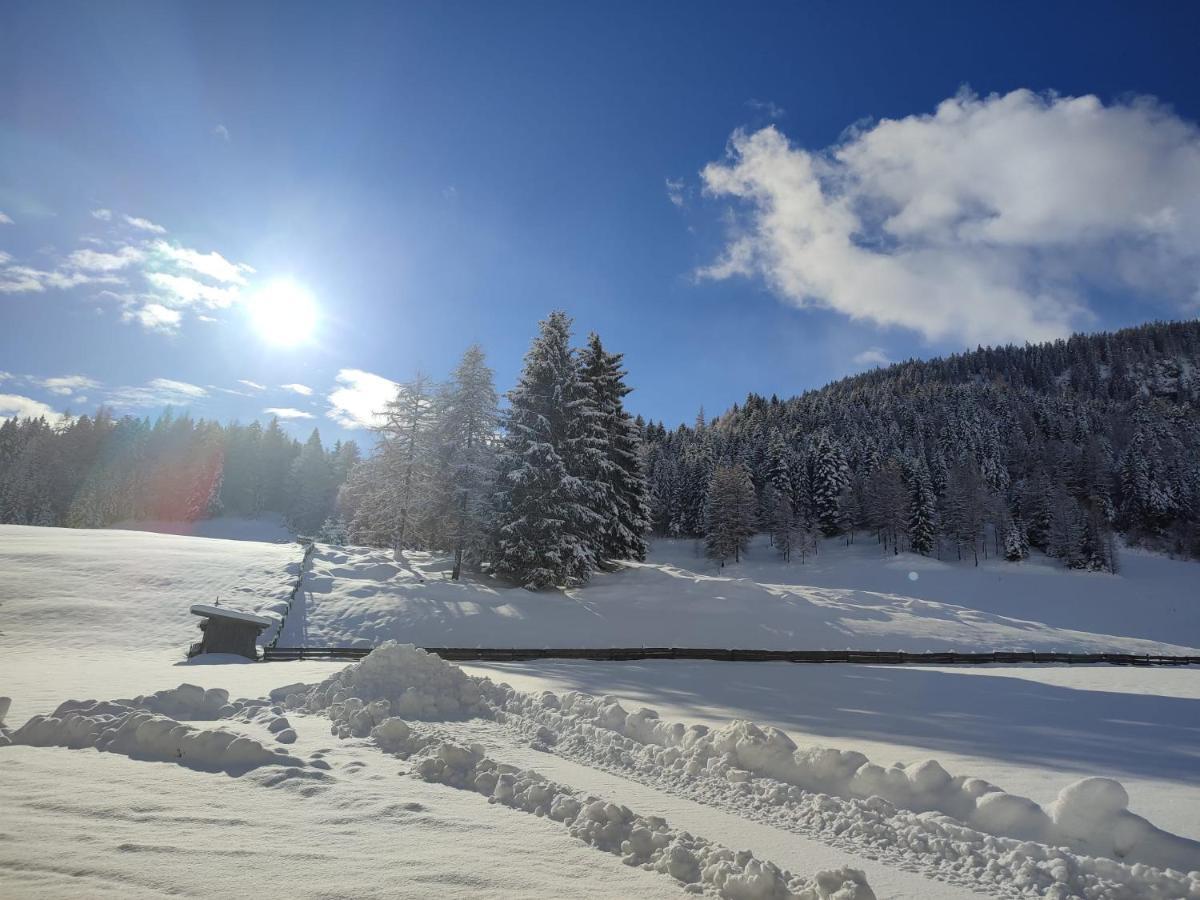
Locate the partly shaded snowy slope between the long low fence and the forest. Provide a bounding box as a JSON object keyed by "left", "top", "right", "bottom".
{"left": 280, "top": 540, "right": 1200, "bottom": 654}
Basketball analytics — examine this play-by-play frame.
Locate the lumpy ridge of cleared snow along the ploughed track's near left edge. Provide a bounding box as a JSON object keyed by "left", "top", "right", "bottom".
{"left": 412, "top": 739, "right": 875, "bottom": 900}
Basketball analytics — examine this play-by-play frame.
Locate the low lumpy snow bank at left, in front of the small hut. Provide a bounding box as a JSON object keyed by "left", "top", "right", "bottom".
{"left": 11, "top": 700, "right": 304, "bottom": 774}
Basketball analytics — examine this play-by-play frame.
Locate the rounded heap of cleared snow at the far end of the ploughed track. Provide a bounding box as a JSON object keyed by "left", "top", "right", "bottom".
{"left": 286, "top": 641, "right": 485, "bottom": 737}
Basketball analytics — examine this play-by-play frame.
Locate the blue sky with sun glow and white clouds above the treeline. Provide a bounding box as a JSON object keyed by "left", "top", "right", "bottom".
{"left": 0, "top": 2, "right": 1200, "bottom": 437}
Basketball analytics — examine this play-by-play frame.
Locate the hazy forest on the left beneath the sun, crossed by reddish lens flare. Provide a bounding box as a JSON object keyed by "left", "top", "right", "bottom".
{"left": 0, "top": 408, "right": 360, "bottom": 534}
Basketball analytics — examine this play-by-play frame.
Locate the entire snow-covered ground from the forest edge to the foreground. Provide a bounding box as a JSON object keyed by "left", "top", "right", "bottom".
{"left": 0, "top": 527, "right": 1200, "bottom": 898}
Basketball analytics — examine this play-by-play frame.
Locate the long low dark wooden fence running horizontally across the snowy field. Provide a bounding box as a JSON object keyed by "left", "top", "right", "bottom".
{"left": 263, "top": 647, "right": 1200, "bottom": 666}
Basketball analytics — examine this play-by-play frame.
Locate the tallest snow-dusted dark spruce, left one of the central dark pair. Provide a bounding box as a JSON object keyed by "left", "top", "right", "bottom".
{"left": 492, "top": 312, "right": 604, "bottom": 589}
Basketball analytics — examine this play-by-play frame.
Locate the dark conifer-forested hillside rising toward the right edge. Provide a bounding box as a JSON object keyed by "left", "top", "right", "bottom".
{"left": 646, "top": 322, "right": 1200, "bottom": 569}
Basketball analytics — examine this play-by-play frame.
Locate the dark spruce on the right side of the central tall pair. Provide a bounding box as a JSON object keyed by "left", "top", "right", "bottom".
{"left": 581, "top": 334, "right": 649, "bottom": 560}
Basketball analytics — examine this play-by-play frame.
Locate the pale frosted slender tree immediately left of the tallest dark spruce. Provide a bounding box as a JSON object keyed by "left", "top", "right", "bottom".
{"left": 437, "top": 344, "right": 499, "bottom": 581}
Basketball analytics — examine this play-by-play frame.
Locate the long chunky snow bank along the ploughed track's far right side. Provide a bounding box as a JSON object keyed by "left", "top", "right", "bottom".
{"left": 492, "top": 683, "right": 1200, "bottom": 883}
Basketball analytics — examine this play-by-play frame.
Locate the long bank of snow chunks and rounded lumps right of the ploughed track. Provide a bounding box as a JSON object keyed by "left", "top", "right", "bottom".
{"left": 484, "top": 684, "right": 1200, "bottom": 899}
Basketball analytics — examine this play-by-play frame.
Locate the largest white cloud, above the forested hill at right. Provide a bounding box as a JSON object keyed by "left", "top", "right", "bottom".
{"left": 698, "top": 90, "right": 1200, "bottom": 343}
